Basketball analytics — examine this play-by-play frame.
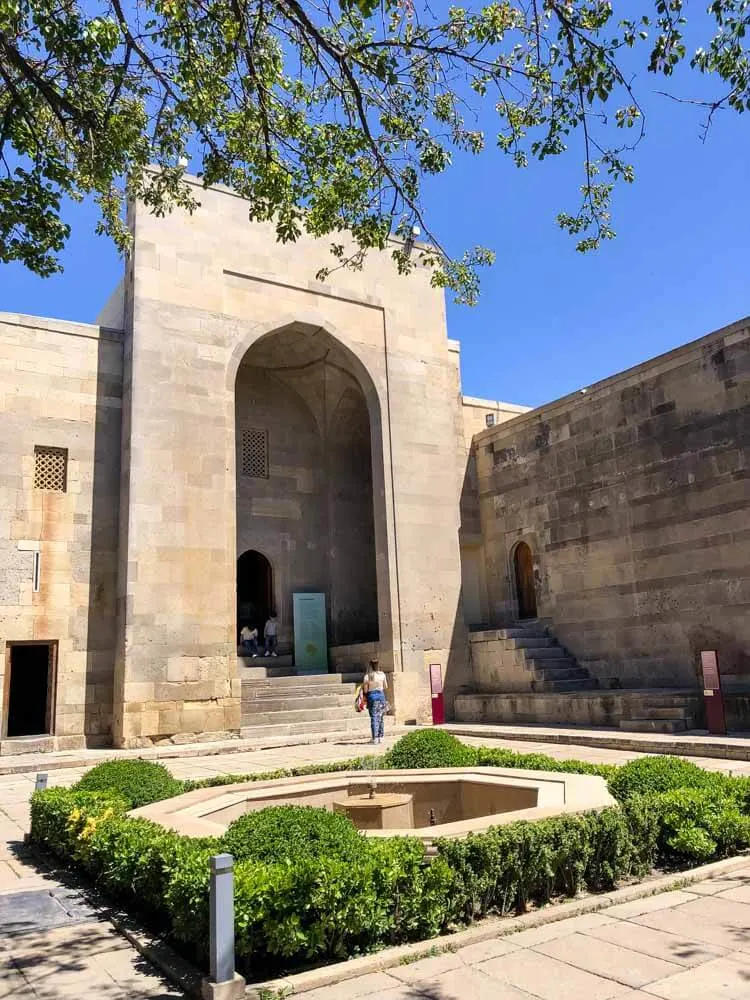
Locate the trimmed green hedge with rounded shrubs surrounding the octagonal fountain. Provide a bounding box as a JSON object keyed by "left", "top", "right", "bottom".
{"left": 26, "top": 730, "right": 750, "bottom": 980}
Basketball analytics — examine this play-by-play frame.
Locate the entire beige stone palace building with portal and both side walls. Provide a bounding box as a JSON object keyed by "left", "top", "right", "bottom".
{"left": 0, "top": 178, "right": 750, "bottom": 753}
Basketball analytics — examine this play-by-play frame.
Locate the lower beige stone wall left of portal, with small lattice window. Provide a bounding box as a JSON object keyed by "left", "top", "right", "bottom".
{"left": 0, "top": 313, "right": 122, "bottom": 751}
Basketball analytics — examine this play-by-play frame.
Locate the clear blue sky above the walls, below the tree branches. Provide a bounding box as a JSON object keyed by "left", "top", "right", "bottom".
{"left": 0, "top": 51, "right": 750, "bottom": 405}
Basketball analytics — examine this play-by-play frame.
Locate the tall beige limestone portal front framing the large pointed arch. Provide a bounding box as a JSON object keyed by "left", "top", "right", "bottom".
{"left": 114, "top": 178, "right": 476, "bottom": 745}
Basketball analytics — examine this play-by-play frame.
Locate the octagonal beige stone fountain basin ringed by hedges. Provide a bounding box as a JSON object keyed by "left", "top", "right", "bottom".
{"left": 130, "top": 767, "right": 615, "bottom": 843}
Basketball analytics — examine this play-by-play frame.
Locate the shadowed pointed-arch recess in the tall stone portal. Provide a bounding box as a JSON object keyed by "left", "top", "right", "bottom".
{"left": 234, "top": 322, "right": 390, "bottom": 651}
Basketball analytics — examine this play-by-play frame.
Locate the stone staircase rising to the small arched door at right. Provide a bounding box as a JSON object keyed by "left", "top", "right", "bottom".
{"left": 471, "top": 620, "right": 598, "bottom": 694}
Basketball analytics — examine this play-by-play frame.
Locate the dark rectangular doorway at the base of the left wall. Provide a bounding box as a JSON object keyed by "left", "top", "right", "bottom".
{"left": 4, "top": 642, "right": 55, "bottom": 737}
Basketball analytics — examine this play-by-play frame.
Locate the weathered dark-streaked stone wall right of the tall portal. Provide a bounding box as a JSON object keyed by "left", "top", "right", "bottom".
{"left": 474, "top": 320, "right": 750, "bottom": 689}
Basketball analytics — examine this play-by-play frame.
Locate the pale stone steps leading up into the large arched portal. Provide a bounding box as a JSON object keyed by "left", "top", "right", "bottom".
{"left": 240, "top": 657, "right": 369, "bottom": 739}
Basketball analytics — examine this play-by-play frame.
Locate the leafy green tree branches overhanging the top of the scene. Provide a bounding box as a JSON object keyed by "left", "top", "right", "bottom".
{"left": 0, "top": 0, "right": 750, "bottom": 302}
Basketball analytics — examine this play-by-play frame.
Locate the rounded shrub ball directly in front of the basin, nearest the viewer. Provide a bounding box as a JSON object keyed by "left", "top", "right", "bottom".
{"left": 222, "top": 806, "right": 365, "bottom": 864}
